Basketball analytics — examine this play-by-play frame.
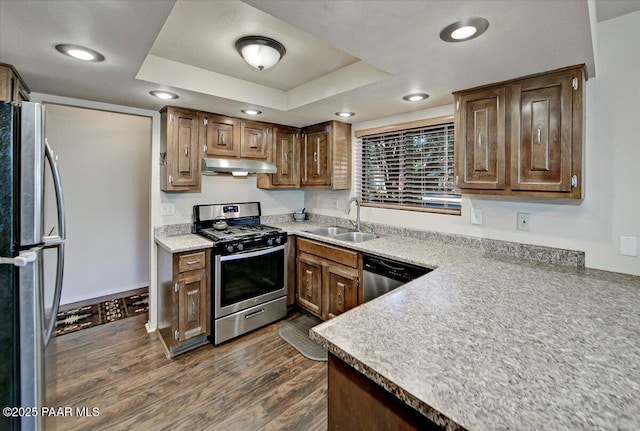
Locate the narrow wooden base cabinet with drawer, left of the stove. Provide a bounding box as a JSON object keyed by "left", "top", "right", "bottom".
{"left": 157, "top": 249, "right": 211, "bottom": 358}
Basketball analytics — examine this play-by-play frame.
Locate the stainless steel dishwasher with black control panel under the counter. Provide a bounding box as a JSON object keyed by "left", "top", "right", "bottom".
{"left": 362, "top": 254, "right": 431, "bottom": 302}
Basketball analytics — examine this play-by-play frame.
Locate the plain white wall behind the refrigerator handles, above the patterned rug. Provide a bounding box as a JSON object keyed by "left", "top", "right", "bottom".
{"left": 45, "top": 104, "right": 151, "bottom": 304}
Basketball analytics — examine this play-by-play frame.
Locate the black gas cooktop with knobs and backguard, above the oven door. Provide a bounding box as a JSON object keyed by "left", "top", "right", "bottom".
{"left": 193, "top": 202, "right": 287, "bottom": 255}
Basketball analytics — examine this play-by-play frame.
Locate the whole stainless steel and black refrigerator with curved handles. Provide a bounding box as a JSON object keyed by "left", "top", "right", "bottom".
{"left": 0, "top": 102, "right": 65, "bottom": 431}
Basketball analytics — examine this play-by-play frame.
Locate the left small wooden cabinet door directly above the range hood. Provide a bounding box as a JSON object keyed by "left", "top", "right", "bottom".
{"left": 200, "top": 113, "right": 240, "bottom": 158}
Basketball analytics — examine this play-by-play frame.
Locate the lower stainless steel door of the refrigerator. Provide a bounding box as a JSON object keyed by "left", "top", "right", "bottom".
{"left": 19, "top": 247, "right": 45, "bottom": 430}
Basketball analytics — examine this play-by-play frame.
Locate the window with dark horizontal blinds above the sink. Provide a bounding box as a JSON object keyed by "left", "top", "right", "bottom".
{"left": 355, "top": 117, "right": 461, "bottom": 215}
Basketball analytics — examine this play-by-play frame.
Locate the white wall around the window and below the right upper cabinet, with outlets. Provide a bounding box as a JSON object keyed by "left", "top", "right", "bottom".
{"left": 305, "top": 12, "right": 640, "bottom": 275}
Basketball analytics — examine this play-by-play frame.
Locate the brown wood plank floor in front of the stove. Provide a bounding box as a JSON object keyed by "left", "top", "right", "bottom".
{"left": 46, "top": 315, "right": 327, "bottom": 431}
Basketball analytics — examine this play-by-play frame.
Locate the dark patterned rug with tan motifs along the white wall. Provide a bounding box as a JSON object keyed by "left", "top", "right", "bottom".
{"left": 55, "top": 292, "right": 149, "bottom": 336}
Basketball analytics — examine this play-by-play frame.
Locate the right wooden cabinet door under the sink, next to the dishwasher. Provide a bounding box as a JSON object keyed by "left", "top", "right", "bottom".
{"left": 323, "top": 265, "right": 360, "bottom": 319}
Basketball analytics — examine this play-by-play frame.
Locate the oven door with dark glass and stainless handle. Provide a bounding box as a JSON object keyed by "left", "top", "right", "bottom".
{"left": 213, "top": 245, "right": 287, "bottom": 319}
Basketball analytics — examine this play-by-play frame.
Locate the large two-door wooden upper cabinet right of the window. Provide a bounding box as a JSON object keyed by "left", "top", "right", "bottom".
{"left": 454, "top": 65, "right": 584, "bottom": 199}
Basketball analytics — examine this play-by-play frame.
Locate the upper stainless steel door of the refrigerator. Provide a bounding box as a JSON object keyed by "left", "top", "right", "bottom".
{"left": 19, "top": 102, "right": 44, "bottom": 247}
